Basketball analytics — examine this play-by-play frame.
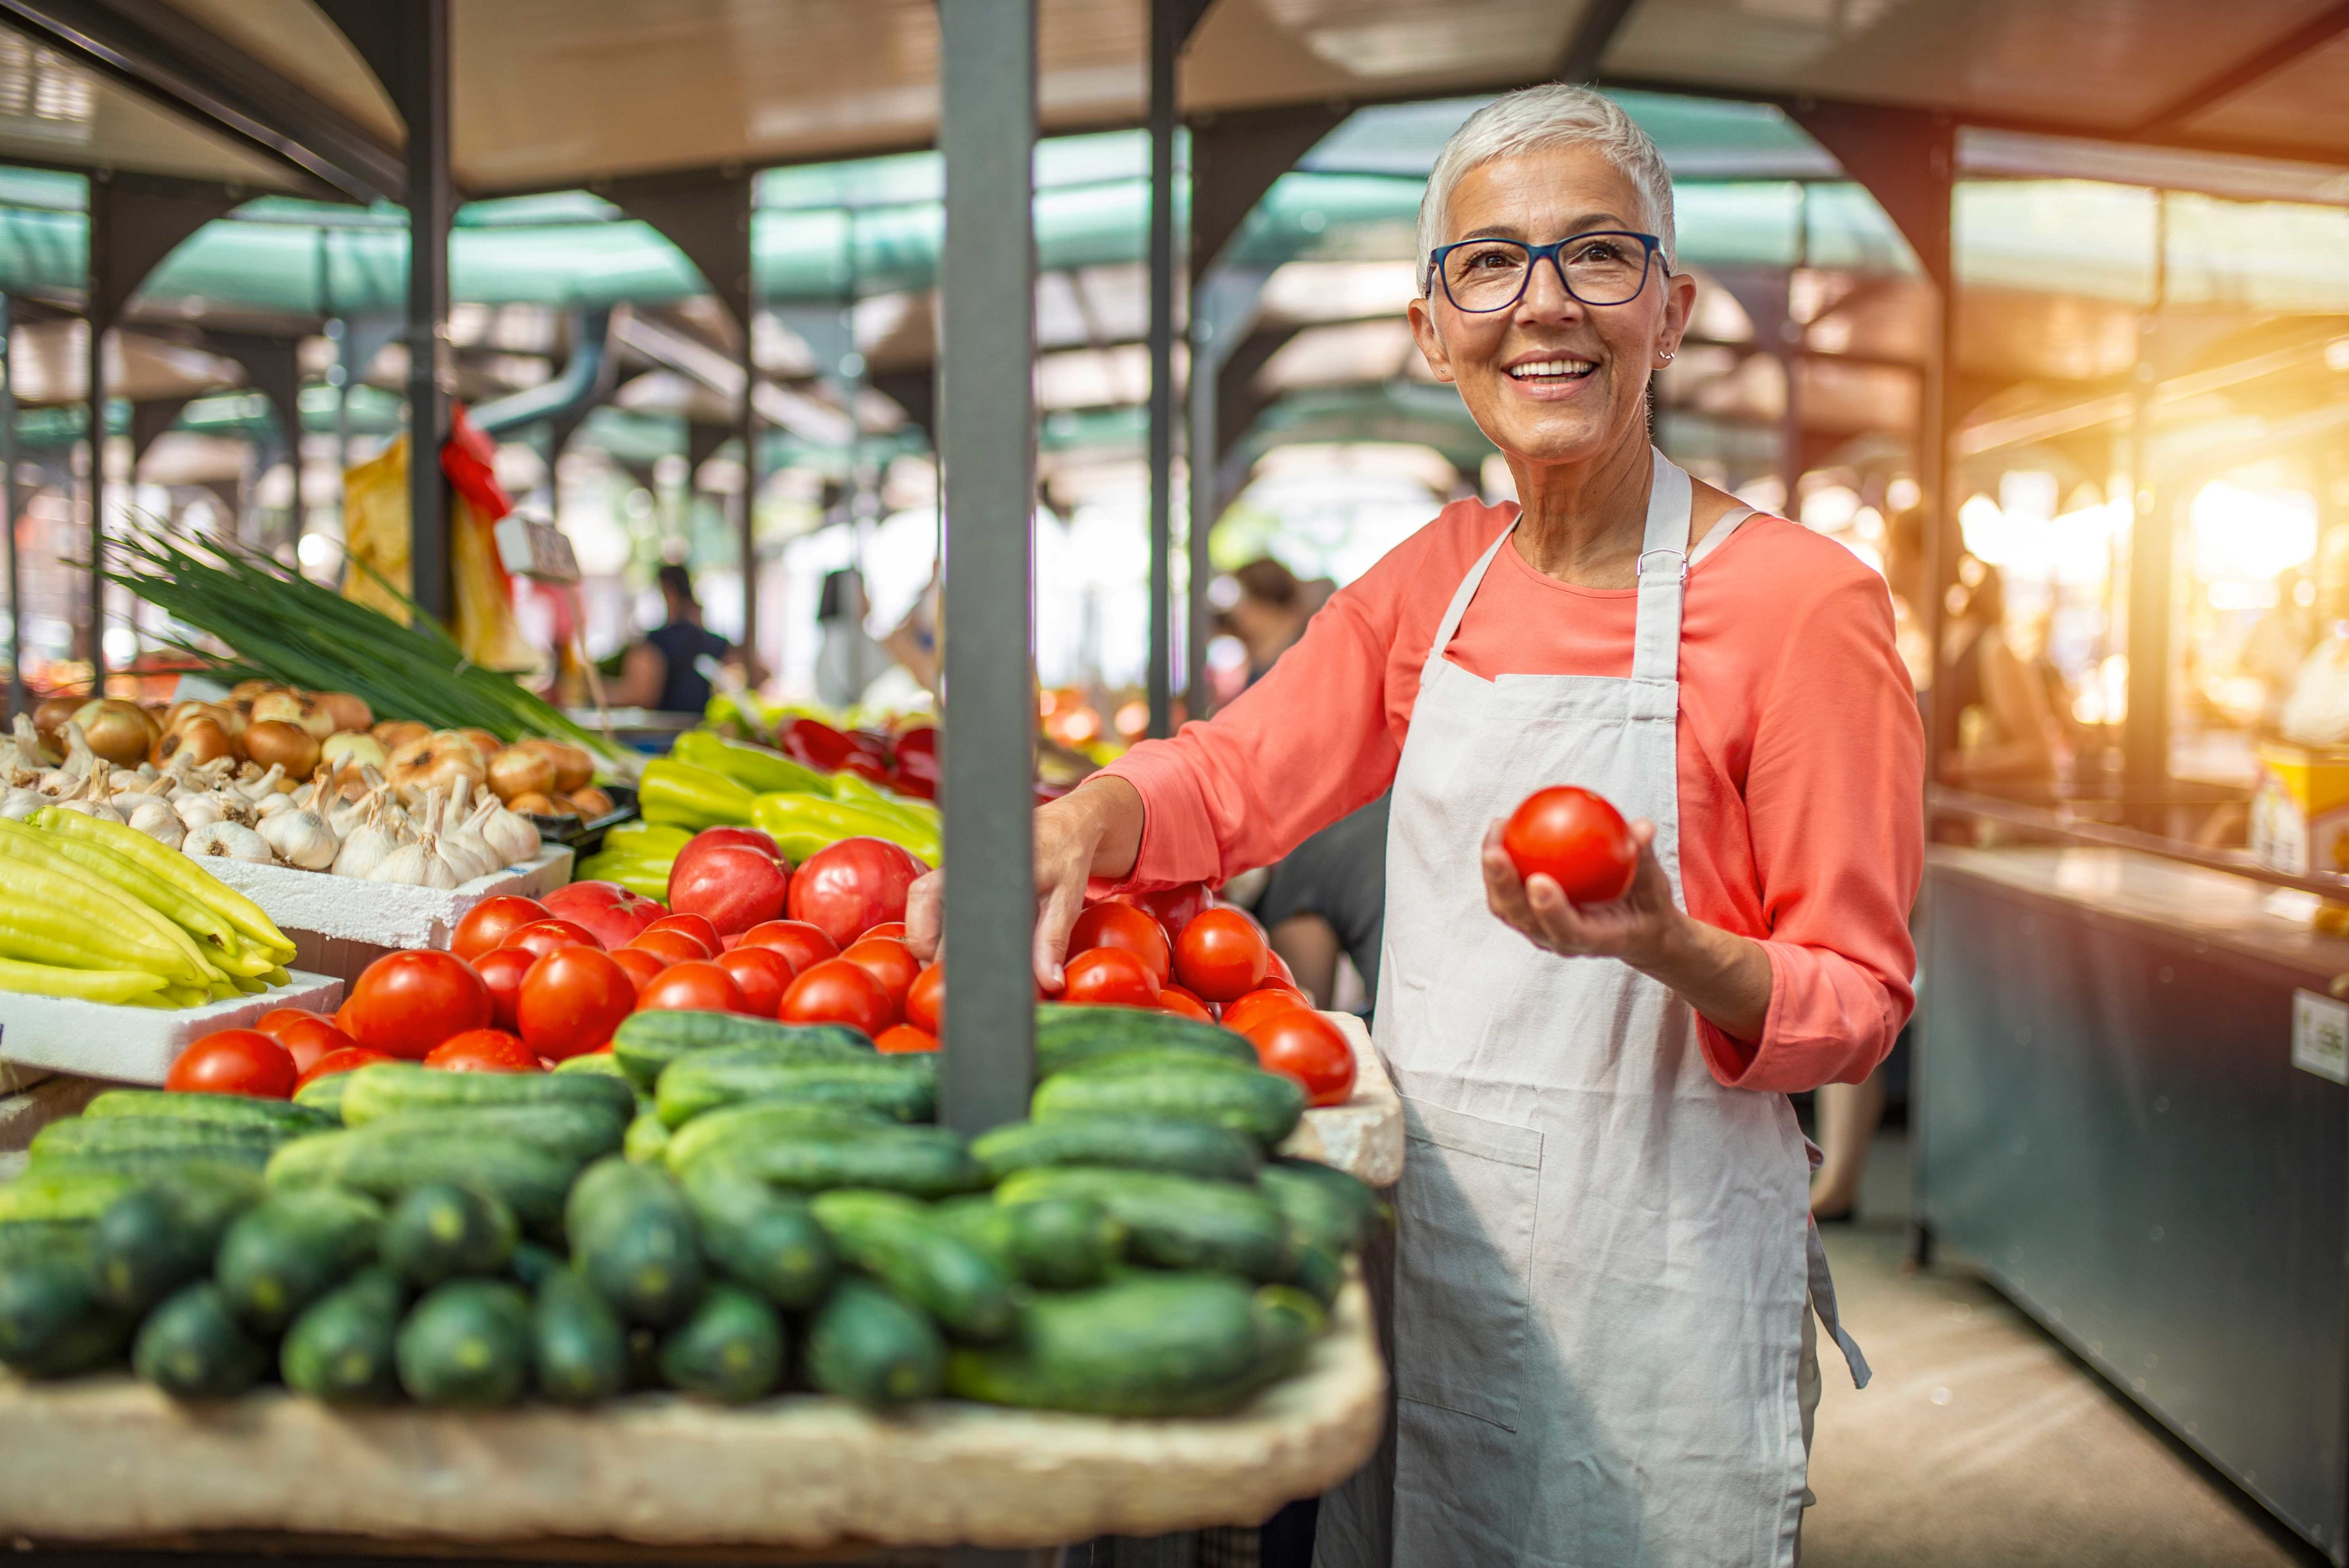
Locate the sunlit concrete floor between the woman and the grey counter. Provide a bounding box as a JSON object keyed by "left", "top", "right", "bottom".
{"left": 1802, "top": 1134, "right": 2323, "bottom": 1568}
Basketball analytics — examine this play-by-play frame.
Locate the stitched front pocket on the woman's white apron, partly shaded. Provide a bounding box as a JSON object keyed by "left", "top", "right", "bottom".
{"left": 1395, "top": 1099, "right": 1541, "bottom": 1432}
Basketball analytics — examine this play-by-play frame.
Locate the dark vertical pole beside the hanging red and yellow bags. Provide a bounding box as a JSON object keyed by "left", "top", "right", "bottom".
{"left": 402, "top": 0, "right": 456, "bottom": 622}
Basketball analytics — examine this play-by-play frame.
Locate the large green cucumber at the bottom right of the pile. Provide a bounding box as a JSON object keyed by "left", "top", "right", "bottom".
{"left": 947, "top": 1274, "right": 1311, "bottom": 1418}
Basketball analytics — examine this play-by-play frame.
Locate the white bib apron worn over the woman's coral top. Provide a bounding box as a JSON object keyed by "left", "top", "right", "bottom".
{"left": 1316, "top": 453, "right": 1868, "bottom": 1568}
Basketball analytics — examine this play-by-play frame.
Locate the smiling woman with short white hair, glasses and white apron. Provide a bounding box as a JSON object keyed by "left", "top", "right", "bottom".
{"left": 923, "top": 87, "right": 1922, "bottom": 1568}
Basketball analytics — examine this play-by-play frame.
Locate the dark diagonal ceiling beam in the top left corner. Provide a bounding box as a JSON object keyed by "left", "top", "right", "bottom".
{"left": 0, "top": 0, "right": 404, "bottom": 202}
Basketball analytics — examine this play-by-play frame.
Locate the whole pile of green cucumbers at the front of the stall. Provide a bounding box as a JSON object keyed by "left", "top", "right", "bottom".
{"left": 0, "top": 1005, "right": 1374, "bottom": 1415}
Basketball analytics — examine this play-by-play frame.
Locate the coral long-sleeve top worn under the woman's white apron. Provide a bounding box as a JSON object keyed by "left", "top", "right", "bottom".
{"left": 1106, "top": 500, "right": 1924, "bottom": 1091}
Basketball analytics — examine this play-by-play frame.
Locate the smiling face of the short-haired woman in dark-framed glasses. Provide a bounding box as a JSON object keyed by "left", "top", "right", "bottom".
{"left": 1409, "top": 145, "right": 1696, "bottom": 479}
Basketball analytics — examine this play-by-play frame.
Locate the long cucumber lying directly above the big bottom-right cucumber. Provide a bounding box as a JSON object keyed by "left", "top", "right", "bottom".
{"left": 996, "top": 1164, "right": 1292, "bottom": 1279}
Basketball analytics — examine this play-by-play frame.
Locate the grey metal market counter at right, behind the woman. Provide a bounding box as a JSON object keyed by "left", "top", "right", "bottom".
{"left": 1914, "top": 845, "right": 2349, "bottom": 1563}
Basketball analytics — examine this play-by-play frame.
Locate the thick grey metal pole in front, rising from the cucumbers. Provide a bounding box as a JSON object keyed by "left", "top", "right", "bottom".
{"left": 937, "top": 0, "right": 1036, "bottom": 1134}
